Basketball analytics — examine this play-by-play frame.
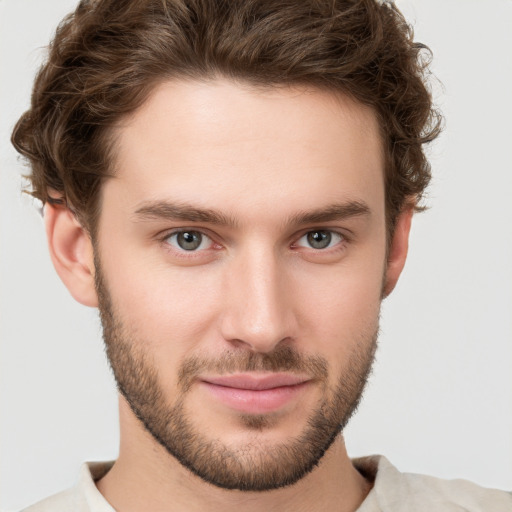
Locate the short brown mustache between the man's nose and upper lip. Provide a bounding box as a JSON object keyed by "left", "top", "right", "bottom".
{"left": 178, "top": 347, "right": 328, "bottom": 391}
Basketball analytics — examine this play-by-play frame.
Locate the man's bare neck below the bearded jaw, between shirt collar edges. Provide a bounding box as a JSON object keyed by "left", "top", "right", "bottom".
{"left": 96, "top": 405, "right": 371, "bottom": 512}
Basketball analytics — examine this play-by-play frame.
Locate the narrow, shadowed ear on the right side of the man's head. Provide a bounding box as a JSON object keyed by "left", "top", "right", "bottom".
{"left": 383, "top": 206, "right": 414, "bottom": 297}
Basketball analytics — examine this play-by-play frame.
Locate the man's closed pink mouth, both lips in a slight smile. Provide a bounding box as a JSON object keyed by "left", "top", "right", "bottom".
{"left": 200, "top": 373, "right": 312, "bottom": 414}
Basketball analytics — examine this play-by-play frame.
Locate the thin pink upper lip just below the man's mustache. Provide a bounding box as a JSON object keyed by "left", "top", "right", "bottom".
{"left": 201, "top": 373, "right": 310, "bottom": 391}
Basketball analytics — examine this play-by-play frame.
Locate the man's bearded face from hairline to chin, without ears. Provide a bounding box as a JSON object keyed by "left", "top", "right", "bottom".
{"left": 95, "top": 80, "right": 386, "bottom": 490}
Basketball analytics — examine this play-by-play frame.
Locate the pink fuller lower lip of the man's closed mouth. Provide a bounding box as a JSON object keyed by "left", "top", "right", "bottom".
{"left": 202, "top": 381, "right": 308, "bottom": 414}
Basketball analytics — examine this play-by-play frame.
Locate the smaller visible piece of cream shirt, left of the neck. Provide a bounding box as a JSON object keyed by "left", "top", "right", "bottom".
{"left": 22, "top": 462, "right": 115, "bottom": 512}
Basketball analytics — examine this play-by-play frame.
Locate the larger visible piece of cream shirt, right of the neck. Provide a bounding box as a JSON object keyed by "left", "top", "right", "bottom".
{"left": 354, "top": 456, "right": 512, "bottom": 512}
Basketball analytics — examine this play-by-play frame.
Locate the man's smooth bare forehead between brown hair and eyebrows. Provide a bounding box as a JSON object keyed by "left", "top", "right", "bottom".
{"left": 103, "top": 79, "right": 384, "bottom": 222}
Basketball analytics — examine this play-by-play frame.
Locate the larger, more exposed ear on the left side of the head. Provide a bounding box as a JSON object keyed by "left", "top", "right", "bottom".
{"left": 44, "top": 203, "right": 98, "bottom": 307}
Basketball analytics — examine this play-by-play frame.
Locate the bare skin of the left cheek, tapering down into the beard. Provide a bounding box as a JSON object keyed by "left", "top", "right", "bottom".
{"left": 105, "top": 262, "right": 226, "bottom": 397}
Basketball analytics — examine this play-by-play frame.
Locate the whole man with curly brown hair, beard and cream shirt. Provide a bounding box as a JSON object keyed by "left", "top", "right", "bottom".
{"left": 7, "top": 2, "right": 511, "bottom": 510}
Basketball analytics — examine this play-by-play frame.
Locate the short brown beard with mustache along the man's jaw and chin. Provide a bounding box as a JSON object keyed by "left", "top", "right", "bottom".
{"left": 95, "top": 258, "right": 378, "bottom": 491}
